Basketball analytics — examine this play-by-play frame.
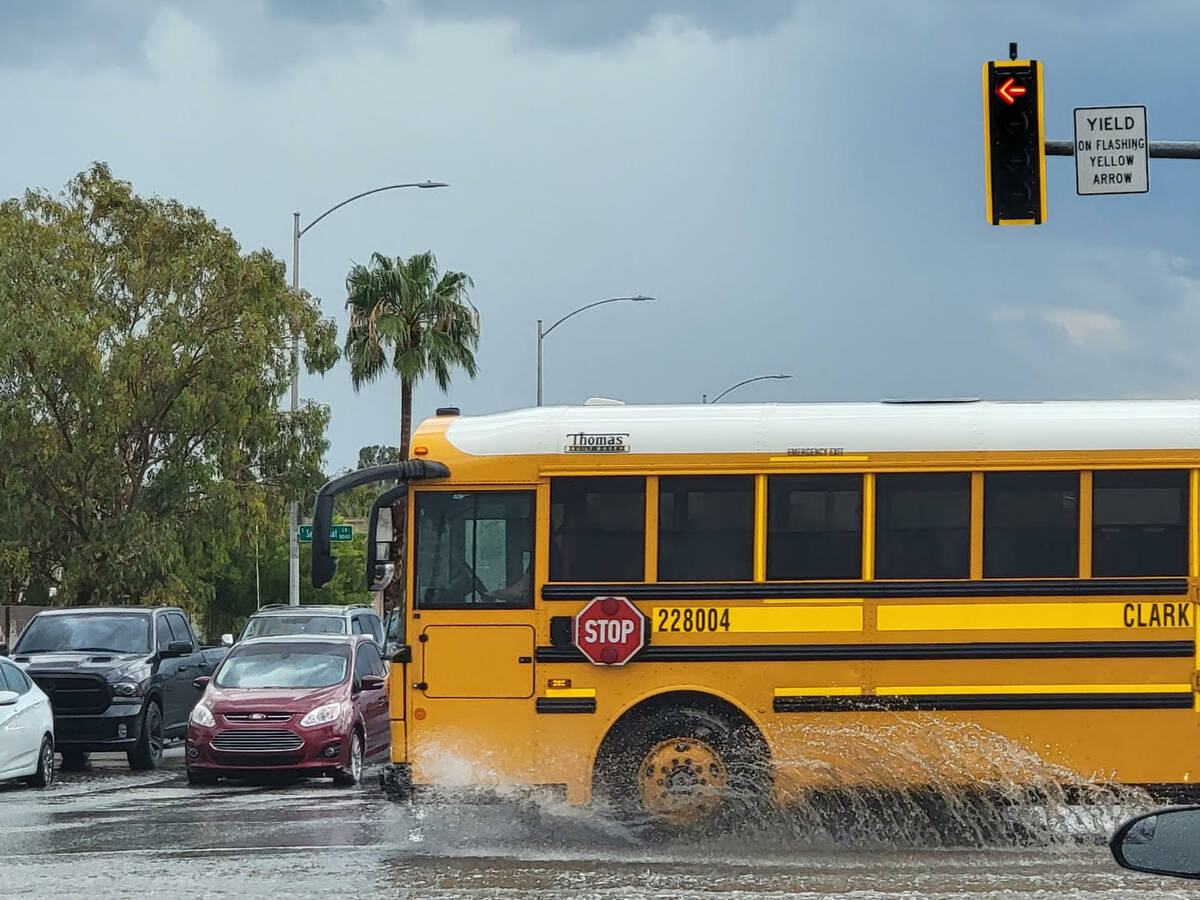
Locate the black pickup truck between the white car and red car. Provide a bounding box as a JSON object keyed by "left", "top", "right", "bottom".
{"left": 5, "top": 606, "right": 228, "bottom": 769}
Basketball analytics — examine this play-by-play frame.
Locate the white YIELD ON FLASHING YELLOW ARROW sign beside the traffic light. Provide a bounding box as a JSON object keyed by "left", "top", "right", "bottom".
{"left": 1075, "top": 107, "right": 1150, "bottom": 194}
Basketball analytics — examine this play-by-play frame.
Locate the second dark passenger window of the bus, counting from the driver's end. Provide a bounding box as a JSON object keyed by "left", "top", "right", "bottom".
{"left": 659, "top": 475, "right": 754, "bottom": 581}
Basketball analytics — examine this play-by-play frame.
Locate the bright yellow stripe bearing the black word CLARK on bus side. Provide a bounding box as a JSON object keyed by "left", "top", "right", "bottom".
{"left": 878, "top": 600, "right": 1194, "bottom": 631}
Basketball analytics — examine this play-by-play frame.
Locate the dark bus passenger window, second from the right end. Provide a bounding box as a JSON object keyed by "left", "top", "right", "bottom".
{"left": 983, "top": 472, "right": 1079, "bottom": 578}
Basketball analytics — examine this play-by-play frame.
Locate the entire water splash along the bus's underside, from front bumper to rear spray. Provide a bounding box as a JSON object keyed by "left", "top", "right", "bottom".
{"left": 414, "top": 714, "right": 1153, "bottom": 852}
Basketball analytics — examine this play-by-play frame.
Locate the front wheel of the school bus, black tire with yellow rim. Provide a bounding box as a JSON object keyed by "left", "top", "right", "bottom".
{"left": 596, "top": 706, "right": 770, "bottom": 834}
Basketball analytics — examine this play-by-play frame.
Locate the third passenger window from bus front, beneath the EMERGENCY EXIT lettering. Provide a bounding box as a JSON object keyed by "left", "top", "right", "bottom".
{"left": 767, "top": 475, "right": 863, "bottom": 581}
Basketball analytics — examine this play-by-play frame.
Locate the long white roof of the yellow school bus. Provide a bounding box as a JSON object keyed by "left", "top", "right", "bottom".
{"left": 433, "top": 400, "right": 1200, "bottom": 456}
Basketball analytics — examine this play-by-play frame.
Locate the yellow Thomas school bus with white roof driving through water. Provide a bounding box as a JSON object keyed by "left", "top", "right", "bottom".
{"left": 313, "top": 401, "right": 1200, "bottom": 826}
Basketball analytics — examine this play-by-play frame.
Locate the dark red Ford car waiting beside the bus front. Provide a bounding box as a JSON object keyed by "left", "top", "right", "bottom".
{"left": 186, "top": 635, "right": 390, "bottom": 786}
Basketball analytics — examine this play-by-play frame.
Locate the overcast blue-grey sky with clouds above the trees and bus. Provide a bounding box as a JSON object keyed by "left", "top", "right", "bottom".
{"left": 0, "top": 0, "right": 1200, "bottom": 469}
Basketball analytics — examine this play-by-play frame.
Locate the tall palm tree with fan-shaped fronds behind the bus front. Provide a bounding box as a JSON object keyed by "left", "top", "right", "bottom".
{"left": 346, "top": 251, "right": 479, "bottom": 460}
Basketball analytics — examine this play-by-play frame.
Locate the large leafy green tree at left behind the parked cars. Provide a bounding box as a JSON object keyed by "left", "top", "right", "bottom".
{"left": 0, "top": 163, "right": 337, "bottom": 612}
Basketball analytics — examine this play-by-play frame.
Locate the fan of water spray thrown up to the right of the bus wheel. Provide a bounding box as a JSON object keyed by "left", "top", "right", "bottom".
{"left": 750, "top": 714, "right": 1151, "bottom": 848}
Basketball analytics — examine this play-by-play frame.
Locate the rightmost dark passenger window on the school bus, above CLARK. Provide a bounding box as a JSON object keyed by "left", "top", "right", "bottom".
{"left": 1092, "top": 472, "right": 1188, "bottom": 576}
